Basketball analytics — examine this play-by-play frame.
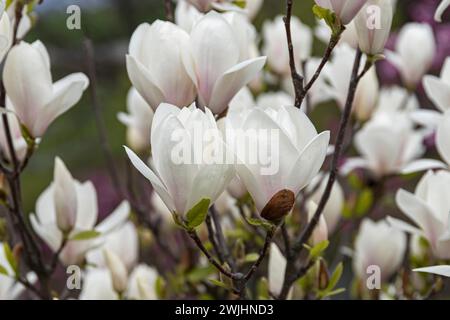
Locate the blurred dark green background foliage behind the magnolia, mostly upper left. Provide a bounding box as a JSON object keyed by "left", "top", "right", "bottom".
{"left": 16, "top": 0, "right": 432, "bottom": 213}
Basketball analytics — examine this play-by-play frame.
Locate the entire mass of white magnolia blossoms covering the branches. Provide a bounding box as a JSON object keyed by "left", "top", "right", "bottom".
{"left": 0, "top": 0, "right": 450, "bottom": 299}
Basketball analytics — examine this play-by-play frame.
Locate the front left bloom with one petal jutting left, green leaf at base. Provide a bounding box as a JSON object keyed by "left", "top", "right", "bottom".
{"left": 125, "top": 104, "right": 234, "bottom": 216}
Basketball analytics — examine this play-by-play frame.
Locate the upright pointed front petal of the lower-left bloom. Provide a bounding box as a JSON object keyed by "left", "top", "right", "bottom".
{"left": 53, "top": 158, "right": 78, "bottom": 232}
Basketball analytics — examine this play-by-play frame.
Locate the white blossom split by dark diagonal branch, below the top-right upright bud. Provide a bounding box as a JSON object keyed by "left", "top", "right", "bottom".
{"left": 324, "top": 44, "right": 379, "bottom": 121}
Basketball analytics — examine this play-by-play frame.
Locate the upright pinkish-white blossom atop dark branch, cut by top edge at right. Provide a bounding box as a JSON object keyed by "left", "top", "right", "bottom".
{"left": 355, "top": 0, "right": 394, "bottom": 55}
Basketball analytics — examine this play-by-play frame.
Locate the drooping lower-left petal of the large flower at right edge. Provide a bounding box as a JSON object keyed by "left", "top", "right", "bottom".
{"left": 395, "top": 189, "right": 445, "bottom": 248}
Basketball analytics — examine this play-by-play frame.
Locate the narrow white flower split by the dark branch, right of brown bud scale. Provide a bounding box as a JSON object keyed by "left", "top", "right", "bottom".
{"left": 306, "top": 173, "right": 345, "bottom": 234}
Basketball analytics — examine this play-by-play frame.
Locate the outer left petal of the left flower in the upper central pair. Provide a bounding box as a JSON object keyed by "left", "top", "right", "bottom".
{"left": 127, "top": 55, "right": 164, "bottom": 110}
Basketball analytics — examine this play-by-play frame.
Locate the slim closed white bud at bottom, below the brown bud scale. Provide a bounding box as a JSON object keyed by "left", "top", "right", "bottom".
{"left": 268, "top": 243, "right": 287, "bottom": 297}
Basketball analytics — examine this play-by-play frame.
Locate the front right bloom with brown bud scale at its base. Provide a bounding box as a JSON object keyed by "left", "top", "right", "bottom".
{"left": 226, "top": 106, "right": 330, "bottom": 220}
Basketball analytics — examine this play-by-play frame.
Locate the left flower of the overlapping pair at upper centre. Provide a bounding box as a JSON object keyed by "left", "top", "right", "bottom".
{"left": 127, "top": 20, "right": 195, "bottom": 110}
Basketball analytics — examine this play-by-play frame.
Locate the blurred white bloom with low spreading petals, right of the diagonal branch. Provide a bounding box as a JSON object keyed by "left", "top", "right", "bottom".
{"left": 341, "top": 112, "right": 425, "bottom": 177}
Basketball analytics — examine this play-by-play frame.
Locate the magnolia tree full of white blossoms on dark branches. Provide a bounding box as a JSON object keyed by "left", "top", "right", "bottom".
{"left": 0, "top": 0, "right": 450, "bottom": 299}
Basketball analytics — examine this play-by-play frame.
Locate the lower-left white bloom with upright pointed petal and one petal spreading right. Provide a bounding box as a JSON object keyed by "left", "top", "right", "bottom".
{"left": 30, "top": 158, "right": 130, "bottom": 265}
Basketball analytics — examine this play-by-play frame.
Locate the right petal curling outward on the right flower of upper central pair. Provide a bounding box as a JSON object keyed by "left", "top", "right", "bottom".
{"left": 208, "top": 57, "right": 267, "bottom": 114}
